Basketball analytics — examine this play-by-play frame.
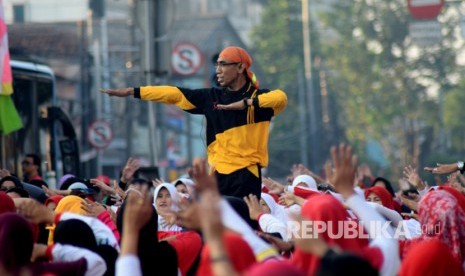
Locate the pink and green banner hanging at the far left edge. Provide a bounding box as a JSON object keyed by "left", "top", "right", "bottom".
{"left": 0, "top": 0, "right": 23, "bottom": 135}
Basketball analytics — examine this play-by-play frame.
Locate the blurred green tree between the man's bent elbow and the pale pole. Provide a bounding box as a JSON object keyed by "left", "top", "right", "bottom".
{"left": 251, "top": 0, "right": 312, "bottom": 176}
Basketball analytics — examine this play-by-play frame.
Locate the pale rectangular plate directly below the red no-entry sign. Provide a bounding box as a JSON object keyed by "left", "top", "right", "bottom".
{"left": 408, "top": 20, "right": 442, "bottom": 47}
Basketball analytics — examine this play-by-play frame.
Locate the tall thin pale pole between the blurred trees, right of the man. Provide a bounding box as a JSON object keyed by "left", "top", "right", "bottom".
{"left": 302, "top": 0, "right": 320, "bottom": 170}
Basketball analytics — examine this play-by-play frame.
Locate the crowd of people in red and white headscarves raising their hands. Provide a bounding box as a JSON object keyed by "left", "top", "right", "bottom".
{"left": 0, "top": 145, "right": 465, "bottom": 275}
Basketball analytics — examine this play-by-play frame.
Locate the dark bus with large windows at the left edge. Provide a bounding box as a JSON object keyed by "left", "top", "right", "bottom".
{"left": 0, "top": 60, "right": 80, "bottom": 181}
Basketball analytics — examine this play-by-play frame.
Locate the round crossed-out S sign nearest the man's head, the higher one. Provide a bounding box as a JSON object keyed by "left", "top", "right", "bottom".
{"left": 171, "top": 42, "right": 203, "bottom": 76}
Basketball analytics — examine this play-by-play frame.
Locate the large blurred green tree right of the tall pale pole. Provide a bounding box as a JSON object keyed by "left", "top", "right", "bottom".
{"left": 321, "top": 0, "right": 462, "bottom": 177}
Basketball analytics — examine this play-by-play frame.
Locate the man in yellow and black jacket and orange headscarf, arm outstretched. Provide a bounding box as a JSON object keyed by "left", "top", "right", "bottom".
{"left": 102, "top": 47, "right": 287, "bottom": 198}
